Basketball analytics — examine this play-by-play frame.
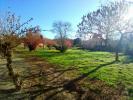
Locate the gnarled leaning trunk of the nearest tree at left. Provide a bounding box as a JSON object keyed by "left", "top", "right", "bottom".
{"left": 6, "top": 49, "right": 21, "bottom": 90}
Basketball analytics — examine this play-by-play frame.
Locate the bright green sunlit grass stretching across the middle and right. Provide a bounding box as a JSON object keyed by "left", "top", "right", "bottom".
{"left": 19, "top": 49, "right": 133, "bottom": 95}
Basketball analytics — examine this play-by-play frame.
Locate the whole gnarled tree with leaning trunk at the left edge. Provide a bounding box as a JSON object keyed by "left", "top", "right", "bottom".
{"left": 0, "top": 12, "right": 32, "bottom": 90}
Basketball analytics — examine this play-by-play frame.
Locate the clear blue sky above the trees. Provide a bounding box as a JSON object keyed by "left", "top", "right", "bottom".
{"left": 0, "top": 0, "right": 103, "bottom": 38}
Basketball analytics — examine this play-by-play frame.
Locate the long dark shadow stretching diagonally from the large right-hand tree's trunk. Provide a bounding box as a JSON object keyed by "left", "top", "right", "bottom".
{"left": 19, "top": 61, "right": 115, "bottom": 100}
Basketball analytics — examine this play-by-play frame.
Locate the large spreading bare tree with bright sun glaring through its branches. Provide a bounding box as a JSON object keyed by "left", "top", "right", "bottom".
{"left": 78, "top": 0, "right": 132, "bottom": 61}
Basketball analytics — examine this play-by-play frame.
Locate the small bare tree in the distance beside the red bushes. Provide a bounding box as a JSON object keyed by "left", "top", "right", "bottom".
{"left": 53, "top": 22, "right": 71, "bottom": 52}
